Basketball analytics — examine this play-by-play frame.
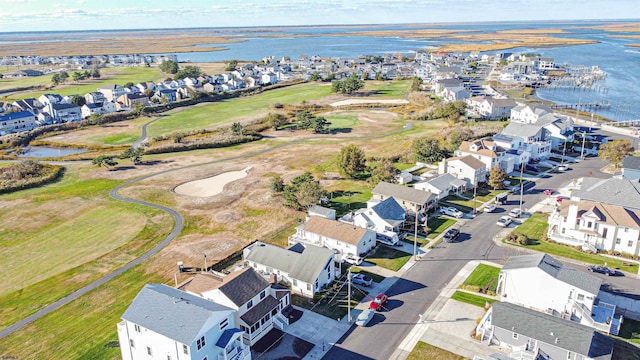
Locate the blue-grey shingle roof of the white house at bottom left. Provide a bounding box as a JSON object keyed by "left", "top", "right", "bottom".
{"left": 122, "top": 284, "right": 233, "bottom": 344}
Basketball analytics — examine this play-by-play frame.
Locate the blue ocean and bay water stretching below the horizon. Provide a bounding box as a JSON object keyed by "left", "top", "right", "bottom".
{"left": 0, "top": 21, "right": 640, "bottom": 121}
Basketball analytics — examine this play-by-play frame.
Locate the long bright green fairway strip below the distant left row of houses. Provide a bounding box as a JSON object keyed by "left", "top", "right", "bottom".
{"left": 147, "top": 83, "right": 331, "bottom": 138}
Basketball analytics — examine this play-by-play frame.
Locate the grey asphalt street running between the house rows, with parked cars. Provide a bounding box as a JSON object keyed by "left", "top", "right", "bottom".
{"left": 324, "top": 158, "right": 638, "bottom": 359}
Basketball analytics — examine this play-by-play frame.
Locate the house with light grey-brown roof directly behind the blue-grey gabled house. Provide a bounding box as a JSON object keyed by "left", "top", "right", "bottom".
{"left": 371, "top": 181, "right": 438, "bottom": 212}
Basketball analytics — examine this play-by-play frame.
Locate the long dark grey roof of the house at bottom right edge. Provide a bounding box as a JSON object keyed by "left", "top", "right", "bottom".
{"left": 491, "top": 302, "right": 614, "bottom": 360}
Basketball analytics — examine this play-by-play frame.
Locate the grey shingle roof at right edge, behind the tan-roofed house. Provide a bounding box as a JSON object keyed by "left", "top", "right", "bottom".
{"left": 571, "top": 177, "right": 640, "bottom": 210}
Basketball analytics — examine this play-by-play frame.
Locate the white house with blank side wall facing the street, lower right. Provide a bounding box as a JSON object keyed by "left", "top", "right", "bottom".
{"left": 496, "top": 253, "right": 621, "bottom": 334}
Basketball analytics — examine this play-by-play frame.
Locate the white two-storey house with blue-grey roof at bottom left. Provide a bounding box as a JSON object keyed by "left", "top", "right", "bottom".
{"left": 118, "top": 284, "right": 251, "bottom": 360}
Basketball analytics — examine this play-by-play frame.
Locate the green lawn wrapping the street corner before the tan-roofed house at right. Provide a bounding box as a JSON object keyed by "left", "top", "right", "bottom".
{"left": 514, "top": 213, "right": 638, "bottom": 274}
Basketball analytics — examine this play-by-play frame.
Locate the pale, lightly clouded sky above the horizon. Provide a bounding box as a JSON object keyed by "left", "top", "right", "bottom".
{"left": 0, "top": 0, "right": 640, "bottom": 32}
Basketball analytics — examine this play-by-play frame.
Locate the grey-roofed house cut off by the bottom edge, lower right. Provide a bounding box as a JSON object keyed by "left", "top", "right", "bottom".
{"left": 476, "top": 302, "right": 615, "bottom": 360}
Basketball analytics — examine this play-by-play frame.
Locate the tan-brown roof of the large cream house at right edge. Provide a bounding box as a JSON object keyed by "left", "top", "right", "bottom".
{"left": 560, "top": 200, "right": 640, "bottom": 229}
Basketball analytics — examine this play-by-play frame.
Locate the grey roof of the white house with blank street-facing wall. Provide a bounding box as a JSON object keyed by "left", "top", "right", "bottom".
{"left": 502, "top": 254, "right": 602, "bottom": 294}
